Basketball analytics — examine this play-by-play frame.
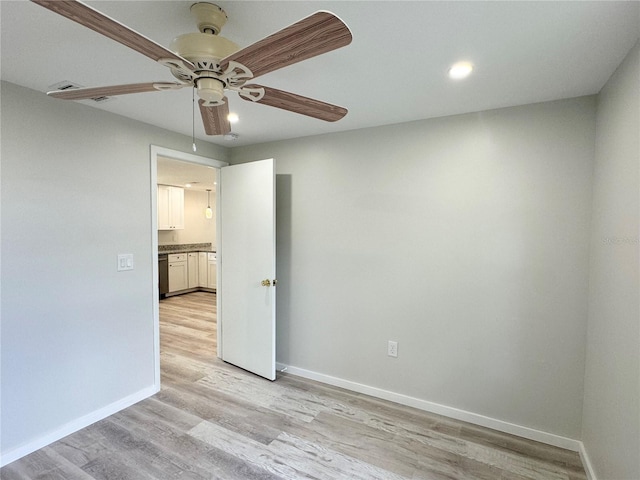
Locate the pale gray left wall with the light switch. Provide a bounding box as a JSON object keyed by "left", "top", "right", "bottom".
{"left": 0, "top": 83, "right": 227, "bottom": 453}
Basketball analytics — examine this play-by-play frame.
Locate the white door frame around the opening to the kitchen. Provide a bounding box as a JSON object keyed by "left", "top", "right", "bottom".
{"left": 149, "top": 145, "right": 229, "bottom": 391}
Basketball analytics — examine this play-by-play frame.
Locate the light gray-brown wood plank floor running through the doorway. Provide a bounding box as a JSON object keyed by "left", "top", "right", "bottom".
{"left": 0, "top": 292, "right": 586, "bottom": 480}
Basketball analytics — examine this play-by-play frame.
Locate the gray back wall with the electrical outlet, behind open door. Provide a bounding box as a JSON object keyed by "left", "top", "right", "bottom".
{"left": 231, "top": 97, "right": 595, "bottom": 439}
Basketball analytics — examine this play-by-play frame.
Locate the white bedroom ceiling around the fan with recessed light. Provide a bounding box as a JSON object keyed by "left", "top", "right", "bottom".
{"left": 0, "top": 0, "right": 640, "bottom": 146}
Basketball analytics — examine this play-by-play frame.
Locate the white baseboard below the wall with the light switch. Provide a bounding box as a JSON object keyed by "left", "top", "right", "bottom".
{"left": 0, "top": 385, "right": 160, "bottom": 467}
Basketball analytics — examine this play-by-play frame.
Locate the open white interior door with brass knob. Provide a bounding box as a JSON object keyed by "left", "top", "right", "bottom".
{"left": 218, "top": 159, "right": 276, "bottom": 380}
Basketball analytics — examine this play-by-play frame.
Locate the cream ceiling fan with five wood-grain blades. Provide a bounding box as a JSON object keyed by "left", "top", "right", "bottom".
{"left": 31, "top": 0, "right": 352, "bottom": 135}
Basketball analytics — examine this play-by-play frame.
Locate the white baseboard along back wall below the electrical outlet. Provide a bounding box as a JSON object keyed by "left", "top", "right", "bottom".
{"left": 278, "top": 364, "right": 584, "bottom": 454}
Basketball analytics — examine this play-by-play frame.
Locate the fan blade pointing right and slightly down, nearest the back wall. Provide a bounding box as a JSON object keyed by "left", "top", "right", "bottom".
{"left": 240, "top": 85, "right": 348, "bottom": 122}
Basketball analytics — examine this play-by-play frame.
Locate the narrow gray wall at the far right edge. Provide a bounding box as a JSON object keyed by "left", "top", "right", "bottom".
{"left": 583, "top": 44, "right": 640, "bottom": 479}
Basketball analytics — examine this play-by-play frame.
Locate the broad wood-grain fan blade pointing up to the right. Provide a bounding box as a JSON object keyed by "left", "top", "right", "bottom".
{"left": 220, "top": 11, "right": 352, "bottom": 78}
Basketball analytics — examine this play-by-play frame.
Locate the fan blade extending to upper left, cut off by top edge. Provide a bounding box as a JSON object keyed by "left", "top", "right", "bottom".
{"left": 31, "top": 0, "right": 195, "bottom": 70}
